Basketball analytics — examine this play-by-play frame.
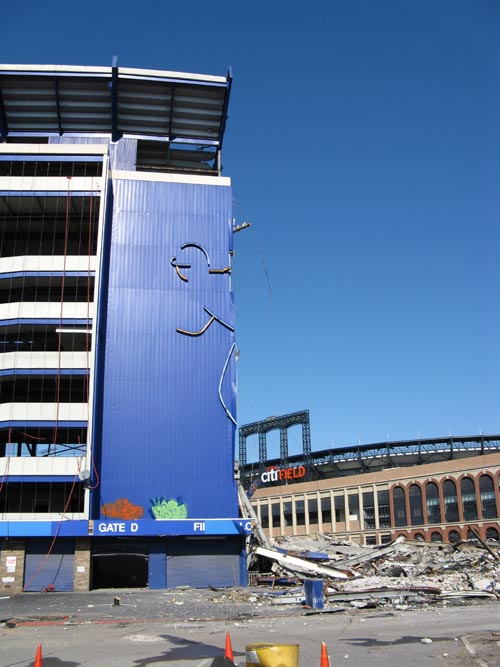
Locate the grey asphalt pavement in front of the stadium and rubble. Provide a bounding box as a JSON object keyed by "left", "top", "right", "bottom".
{"left": 0, "top": 588, "right": 500, "bottom": 667}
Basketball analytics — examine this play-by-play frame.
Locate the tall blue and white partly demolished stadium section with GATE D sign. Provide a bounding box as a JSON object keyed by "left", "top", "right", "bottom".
{"left": 0, "top": 60, "right": 250, "bottom": 593}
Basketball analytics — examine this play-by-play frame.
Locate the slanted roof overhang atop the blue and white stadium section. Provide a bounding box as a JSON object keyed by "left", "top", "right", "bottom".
{"left": 0, "top": 59, "right": 232, "bottom": 152}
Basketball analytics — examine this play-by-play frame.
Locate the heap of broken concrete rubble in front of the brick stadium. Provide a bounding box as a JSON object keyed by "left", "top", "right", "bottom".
{"left": 250, "top": 535, "right": 500, "bottom": 612}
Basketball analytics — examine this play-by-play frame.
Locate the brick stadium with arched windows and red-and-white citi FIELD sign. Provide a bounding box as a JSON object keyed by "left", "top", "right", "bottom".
{"left": 239, "top": 411, "right": 500, "bottom": 545}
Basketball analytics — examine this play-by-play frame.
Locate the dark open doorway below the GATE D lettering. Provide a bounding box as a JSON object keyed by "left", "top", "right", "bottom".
{"left": 92, "top": 553, "right": 148, "bottom": 589}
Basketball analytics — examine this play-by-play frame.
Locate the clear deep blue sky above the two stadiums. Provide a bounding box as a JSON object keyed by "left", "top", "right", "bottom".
{"left": 0, "top": 0, "right": 500, "bottom": 450}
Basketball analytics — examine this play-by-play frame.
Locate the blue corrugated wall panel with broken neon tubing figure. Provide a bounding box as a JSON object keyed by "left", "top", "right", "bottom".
{"left": 94, "top": 180, "right": 238, "bottom": 519}
